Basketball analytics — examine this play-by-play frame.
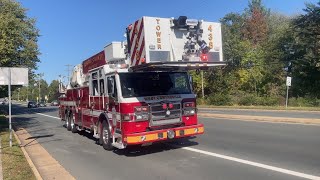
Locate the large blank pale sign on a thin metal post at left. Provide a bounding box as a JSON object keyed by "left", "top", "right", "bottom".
{"left": 0, "top": 67, "right": 29, "bottom": 147}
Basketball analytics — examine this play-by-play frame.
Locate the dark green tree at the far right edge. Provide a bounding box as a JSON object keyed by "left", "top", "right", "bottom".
{"left": 292, "top": 2, "right": 320, "bottom": 98}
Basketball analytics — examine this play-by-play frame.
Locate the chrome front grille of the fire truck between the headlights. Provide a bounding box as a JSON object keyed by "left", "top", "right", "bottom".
{"left": 150, "top": 102, "right": 181, "bottom": 126}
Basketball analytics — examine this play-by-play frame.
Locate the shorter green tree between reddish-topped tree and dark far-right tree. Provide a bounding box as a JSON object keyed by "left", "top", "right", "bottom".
{"left": 261, "top": 12, "right": 293, "bottom": 96}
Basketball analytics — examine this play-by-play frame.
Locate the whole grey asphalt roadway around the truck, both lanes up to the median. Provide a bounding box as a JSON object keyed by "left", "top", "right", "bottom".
{"left": 13, "top": 106, "right": 320, "bottom": 180}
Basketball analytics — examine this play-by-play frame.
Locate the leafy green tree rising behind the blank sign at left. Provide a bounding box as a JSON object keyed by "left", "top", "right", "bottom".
{"left": 0, "top": 0, "right": 40, "bottom": 96}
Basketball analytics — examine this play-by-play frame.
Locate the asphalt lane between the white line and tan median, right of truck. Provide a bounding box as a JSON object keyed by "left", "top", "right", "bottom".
{"left": 197, "top": 118, "right": 320, "bottom": 176}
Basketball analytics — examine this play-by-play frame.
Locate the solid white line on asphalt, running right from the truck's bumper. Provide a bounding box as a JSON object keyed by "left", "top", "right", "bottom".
{"left": 181, "top": 147, "right": 320, "bottom": 180}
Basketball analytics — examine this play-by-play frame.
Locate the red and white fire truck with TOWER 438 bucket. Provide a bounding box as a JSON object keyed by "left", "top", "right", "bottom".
{"left": 59, "top": 16, "right": 225, "bottom": 150}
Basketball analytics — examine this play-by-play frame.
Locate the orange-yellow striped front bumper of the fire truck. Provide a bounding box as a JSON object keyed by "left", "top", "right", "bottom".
{"left": 123, "top": 124, "right": 204, "bottom": 145}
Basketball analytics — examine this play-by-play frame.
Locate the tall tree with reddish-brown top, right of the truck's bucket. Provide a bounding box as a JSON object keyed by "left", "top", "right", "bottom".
{"left": 221, "top": 0, "right": 269, "bottom": 94}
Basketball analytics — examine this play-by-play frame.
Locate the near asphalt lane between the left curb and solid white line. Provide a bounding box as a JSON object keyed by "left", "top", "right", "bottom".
{"left": 11, "top": 105, "right": 304, "bottom": 179}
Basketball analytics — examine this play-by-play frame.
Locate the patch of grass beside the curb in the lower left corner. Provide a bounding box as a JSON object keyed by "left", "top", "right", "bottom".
{"left": 0, "top": 115, "right": 36, "bottom": 180}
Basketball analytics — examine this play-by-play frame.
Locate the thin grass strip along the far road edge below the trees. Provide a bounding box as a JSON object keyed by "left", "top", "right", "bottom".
{"left": 198, "top": 105, "right": 320, "bottom": 111}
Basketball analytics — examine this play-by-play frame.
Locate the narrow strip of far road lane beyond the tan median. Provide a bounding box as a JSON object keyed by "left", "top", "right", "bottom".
{"left": 199, "top": 108, "right": 320, "bottom": 119}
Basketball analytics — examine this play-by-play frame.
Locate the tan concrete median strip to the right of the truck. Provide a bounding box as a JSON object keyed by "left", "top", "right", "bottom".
{"left": 198, "top": 113, "right": 320, "bottom": 126}
